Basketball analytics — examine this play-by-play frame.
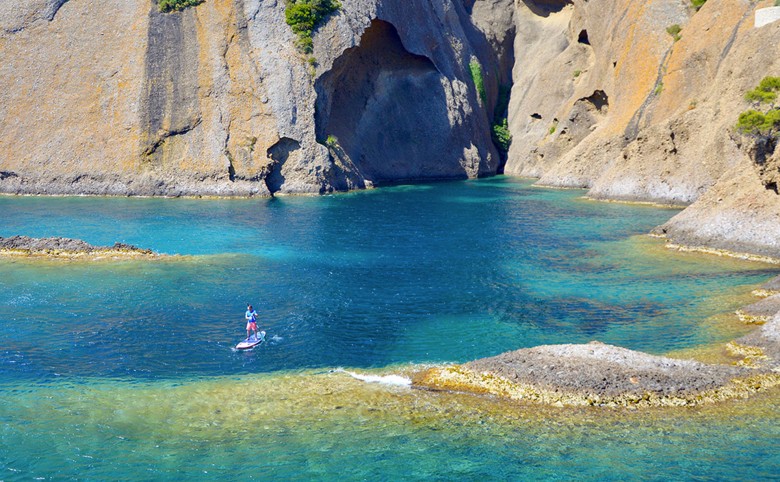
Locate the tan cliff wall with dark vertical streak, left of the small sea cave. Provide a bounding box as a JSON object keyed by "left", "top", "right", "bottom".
{"left": 0, "top": 0, "right": 278, "bottom": 195}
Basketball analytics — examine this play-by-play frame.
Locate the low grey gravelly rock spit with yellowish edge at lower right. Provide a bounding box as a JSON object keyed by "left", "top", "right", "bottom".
{"left": 414, "top": 277, "right": 780, "bottom": 407}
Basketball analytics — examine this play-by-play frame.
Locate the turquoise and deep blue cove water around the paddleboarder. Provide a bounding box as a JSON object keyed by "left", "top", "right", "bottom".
{"left": 0, "top": 178, "right": 780, "bottom": 480}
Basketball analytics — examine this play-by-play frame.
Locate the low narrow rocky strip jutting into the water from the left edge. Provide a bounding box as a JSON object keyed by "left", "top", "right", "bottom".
{"left": 0, "top": 236, "right": 165, "bottom": 260}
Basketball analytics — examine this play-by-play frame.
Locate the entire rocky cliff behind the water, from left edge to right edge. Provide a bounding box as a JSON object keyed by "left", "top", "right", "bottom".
{"left": 0, "top": 0, "right": 780, "bottom": 257}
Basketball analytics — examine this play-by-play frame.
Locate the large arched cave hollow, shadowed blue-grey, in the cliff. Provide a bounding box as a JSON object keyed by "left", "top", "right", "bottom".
{"left": 315, "top": 20, "right": 465, "bottom": 182}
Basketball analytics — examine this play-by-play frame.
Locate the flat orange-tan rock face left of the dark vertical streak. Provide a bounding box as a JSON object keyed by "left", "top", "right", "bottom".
{"left": 0, "top": 0, "right": 148, "bottom": 190}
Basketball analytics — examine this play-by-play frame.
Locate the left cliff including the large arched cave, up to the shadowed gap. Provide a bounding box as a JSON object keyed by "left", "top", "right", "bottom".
{"left": 0, "top": 0, "right": 499, "bottom": 195}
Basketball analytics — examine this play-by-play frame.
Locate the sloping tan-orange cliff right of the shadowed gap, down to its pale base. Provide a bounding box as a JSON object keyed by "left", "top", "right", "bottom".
{"left": 506, "top": 0, "right": 780, "bottom": 256}
